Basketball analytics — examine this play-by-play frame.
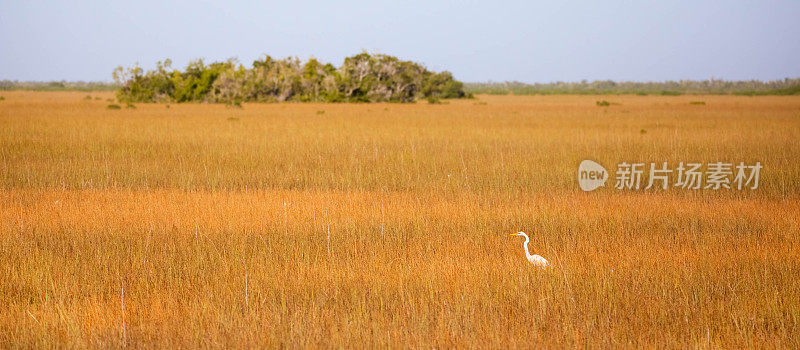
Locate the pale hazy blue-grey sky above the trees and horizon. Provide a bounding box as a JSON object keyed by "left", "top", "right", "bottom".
{"left": 0, "top": 0, "right": 800, "bottom": 82}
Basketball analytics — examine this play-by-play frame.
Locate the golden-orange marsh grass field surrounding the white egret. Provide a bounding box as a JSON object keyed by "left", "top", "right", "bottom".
{"left": 0, "top": 92, "right": 800, "bottom": 348}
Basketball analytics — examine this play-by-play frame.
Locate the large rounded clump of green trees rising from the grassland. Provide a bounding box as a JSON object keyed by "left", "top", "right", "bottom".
{"left": 109, "top": 53, "right": 467, "bottom": 105}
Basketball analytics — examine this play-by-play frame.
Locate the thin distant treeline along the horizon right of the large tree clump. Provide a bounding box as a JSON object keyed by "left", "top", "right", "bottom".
{"left": 465, "top": 78, "right": 800, "bottom": 95}
